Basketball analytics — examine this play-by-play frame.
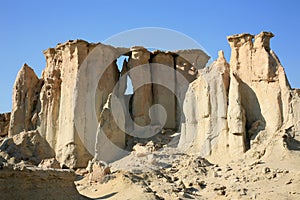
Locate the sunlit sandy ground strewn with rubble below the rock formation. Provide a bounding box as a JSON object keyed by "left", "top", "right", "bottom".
{"left": 75, "top": 137, "right": 300, "bottom": 200}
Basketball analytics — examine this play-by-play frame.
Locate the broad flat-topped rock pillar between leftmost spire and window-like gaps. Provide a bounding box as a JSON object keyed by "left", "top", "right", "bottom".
{"left": 38, "top": 40, "right": 127, "bottom": 168}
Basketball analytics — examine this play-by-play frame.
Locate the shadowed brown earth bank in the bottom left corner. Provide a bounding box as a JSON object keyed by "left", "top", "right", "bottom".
{"left": 0, "top": 165, "right": 86, "bottom": 200}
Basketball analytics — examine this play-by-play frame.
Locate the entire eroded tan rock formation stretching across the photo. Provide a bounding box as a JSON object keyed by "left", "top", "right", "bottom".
{"left": 5, "top": 32, "right": 300, "bottom": 168}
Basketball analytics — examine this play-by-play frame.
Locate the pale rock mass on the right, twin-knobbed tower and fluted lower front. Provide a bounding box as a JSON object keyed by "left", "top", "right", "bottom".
{"left": 179, "top": 32, "right": 299, "bottom": 159}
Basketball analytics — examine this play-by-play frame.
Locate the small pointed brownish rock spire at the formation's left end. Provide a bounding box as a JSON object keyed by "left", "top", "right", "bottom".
{"left": 9, "top": 64, "right": 41, "bottom": 137}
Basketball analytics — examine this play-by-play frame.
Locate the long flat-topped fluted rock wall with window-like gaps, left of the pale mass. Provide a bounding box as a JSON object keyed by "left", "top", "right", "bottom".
{"left": 9, "top": 40, "right": 209, "bottom": 168}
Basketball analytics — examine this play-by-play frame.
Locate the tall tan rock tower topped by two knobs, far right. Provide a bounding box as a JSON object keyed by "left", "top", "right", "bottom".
{"left": 228, "top": 32, "right": 290, "bottom": 143}
